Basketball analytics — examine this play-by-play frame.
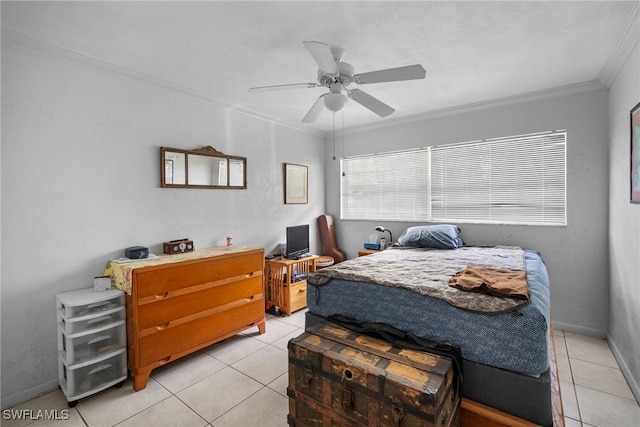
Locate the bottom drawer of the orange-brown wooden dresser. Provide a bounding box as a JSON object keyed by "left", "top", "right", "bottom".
{"left": 138, "top": 297, "right": 264, "bottom": 366}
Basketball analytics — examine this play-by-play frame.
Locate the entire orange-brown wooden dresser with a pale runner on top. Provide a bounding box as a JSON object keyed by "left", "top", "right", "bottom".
{"left": 105, "top": 246, "right": 265, "bottom": 391}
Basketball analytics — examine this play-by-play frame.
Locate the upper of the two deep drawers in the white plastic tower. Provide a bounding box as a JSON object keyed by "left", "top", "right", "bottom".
{"left": 58, "top": 320, "right": 127, "bottom": 366}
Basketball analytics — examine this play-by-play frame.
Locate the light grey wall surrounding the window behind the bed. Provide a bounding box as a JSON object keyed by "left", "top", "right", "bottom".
{"left": 325, "top": 85, "right": 609, "bottom": 337}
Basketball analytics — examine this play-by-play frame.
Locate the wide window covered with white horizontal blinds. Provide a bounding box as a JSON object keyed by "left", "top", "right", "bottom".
{"left": 341, "top": 131, "right": 567, "bottom": 225}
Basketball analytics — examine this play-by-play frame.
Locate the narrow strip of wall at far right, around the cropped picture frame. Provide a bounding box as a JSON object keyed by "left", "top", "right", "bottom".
{"left": 608, "top": 10, "right": 640, "bottom": 401}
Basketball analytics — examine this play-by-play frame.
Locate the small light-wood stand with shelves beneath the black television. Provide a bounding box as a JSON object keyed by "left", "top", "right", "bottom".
{"left": 264, "top": 255, "right": 319, "bottom": 316}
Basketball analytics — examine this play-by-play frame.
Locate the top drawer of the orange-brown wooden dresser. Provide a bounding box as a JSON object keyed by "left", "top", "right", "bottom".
{"left": 134, "top": 251, "right": 264, "bottom": 297}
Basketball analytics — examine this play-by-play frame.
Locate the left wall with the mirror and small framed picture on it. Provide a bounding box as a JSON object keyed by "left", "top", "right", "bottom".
{"left": 1, "top": 44, "right": 324, "bottom": 408}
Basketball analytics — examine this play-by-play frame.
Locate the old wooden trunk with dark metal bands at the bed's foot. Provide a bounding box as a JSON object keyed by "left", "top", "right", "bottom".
{"left": 287, "top": 322, "right": 460, "bottom": 427}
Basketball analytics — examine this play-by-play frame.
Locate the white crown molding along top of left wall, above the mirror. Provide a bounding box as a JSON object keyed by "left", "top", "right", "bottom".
{"left": 0, "top": 30, "right": 324, "bottom": 137}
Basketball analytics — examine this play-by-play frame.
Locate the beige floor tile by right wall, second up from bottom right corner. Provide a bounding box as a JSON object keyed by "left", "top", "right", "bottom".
{"left": 571, "top": 359, "right": 634, "bottom": 399}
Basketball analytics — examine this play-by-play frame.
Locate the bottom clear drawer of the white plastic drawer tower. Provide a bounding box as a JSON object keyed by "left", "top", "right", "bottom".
{"left": 58, "top": 348, "right": 127, "bottom": 399}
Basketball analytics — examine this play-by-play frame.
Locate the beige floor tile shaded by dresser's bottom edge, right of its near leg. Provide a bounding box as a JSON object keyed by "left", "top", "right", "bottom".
{"left": 151, "top": 352, "right": 226, "bottom": 394}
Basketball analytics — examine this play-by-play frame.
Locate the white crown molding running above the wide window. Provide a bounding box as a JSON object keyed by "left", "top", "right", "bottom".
{"left": 336, "top": 80, "right": 607, "bottom": 138}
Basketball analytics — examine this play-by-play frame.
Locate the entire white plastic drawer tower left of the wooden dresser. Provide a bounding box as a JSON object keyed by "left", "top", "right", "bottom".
{"left": 56, "top": 288, "right": 127, "bottom": 407}
